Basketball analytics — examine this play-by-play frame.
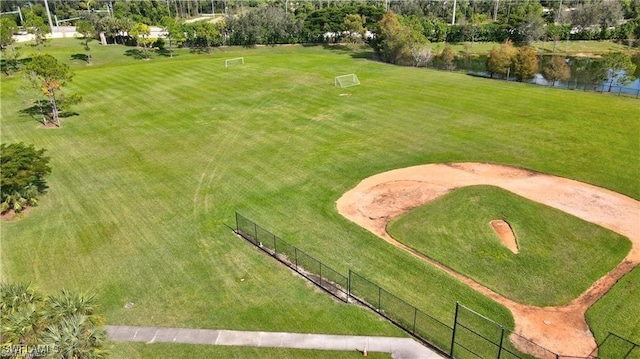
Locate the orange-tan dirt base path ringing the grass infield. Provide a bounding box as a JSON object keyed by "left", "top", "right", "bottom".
{"left": 337, "top": 163, "right": 640, "bottom": 357}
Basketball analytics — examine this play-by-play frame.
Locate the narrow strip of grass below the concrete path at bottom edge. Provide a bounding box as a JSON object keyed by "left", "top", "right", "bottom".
{"left": 111, "top": 343, "right": 391, "bottom": 359}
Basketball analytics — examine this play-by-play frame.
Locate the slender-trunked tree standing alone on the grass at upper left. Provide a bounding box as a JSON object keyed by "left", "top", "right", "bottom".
{"left": 27, "top": 54, "right": 73, "bottom": 126}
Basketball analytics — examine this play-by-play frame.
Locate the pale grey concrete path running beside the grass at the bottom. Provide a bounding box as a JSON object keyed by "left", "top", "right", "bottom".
{"left": 105, "top": 325, "right": 442, "bottom": 359}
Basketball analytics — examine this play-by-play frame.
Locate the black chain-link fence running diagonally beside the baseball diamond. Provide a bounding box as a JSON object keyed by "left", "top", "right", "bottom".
{"left": 236, "top": 213, "right": 640, "bottom": 359}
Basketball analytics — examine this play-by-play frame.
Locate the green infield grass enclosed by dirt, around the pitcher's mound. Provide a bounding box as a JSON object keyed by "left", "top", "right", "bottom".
{"left": 387, "top": 186, "right": 631, "bottom": 307}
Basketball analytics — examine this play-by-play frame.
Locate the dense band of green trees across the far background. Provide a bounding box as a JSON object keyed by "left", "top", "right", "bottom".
{"left": 0, "top": 0, "right": 640, "bottom": 46}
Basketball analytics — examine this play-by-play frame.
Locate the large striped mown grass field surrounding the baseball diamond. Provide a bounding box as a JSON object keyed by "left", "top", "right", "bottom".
{"left": 0, "top": 39, "right": 640, "bottom": 357}
